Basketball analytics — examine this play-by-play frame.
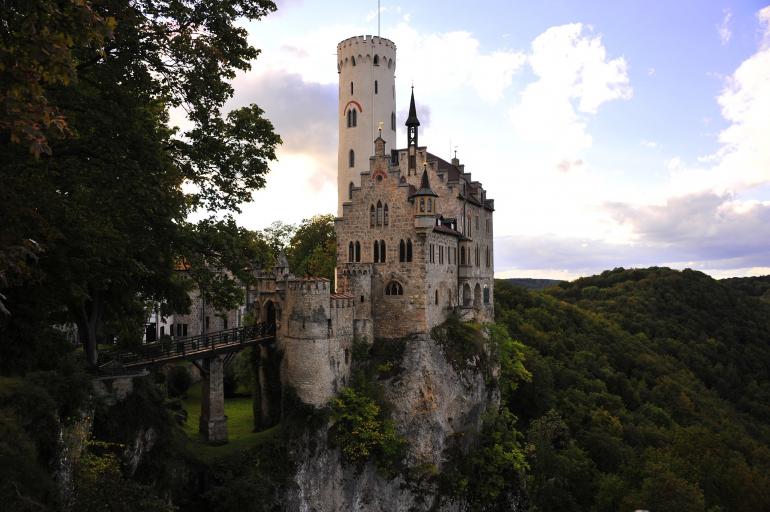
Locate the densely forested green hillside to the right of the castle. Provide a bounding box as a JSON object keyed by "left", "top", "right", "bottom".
{"left": 496, "top": 268, "right": 770, "bottom": 512}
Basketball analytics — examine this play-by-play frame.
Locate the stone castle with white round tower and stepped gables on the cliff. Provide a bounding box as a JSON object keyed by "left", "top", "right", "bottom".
{"left": 152, "top": 36, "right": 494, "bottom": 416}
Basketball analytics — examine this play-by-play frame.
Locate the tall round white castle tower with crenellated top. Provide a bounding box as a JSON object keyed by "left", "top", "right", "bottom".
{"left": 337, "top": 36, "right": 396, "bottom": 216}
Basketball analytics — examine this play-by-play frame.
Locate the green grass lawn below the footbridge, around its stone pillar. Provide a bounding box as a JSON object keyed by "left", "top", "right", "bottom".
{"left": 183, "top": 382, "right": 278, "bottom": 462}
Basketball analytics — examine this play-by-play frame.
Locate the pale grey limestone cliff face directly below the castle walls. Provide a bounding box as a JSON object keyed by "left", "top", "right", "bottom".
{"left": 285, "top": 334, "right": 499, "bottom": 512}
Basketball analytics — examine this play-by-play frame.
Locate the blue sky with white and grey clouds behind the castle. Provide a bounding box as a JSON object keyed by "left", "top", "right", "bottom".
{"left": 214, "top": 0, "right": 770, "bottom": 279}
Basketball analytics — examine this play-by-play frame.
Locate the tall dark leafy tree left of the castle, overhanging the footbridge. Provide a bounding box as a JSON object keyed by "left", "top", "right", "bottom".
{"left": 0, "top": 0, "right": 280, "bottom": 365}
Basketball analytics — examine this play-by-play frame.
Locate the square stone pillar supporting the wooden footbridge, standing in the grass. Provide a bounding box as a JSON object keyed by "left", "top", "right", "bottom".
{"left": 198, "top": 356, "right": 227, "bottom": 444}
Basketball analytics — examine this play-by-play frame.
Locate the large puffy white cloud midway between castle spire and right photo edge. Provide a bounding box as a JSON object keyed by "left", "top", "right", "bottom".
{"left": 509, "top": 23, "right": 632, "bottom": 159}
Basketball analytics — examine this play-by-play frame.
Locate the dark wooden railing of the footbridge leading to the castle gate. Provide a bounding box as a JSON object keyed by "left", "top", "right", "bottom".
{"left": 116, "top": 323, "right": 275, "bottom": 365}
